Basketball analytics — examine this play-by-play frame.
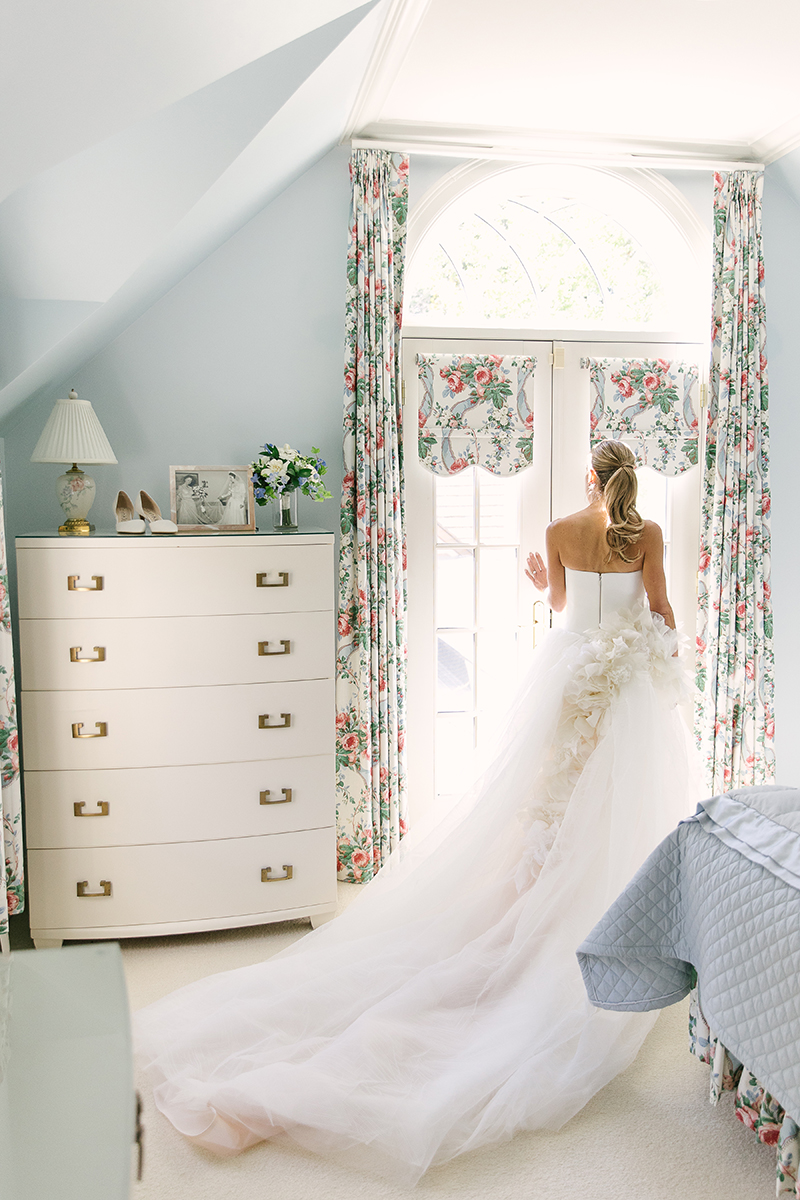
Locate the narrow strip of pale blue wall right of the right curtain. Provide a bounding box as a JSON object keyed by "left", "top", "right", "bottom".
{"left": 764, "top": 150, "right": 800, "bottom": 787}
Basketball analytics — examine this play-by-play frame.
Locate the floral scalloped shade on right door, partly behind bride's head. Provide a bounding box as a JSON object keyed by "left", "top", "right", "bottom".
{"left": 589, "top": 359, "right": 700, "bottom": 475}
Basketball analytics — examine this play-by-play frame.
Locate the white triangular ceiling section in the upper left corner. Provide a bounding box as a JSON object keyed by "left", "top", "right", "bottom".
{"left": 0, "top": 0, "right": 371, "bottom": 199}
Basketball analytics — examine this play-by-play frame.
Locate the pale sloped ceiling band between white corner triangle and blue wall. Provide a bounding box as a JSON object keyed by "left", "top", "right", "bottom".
{"left": 0, "top": 0, "right": 385, "bottom": 419}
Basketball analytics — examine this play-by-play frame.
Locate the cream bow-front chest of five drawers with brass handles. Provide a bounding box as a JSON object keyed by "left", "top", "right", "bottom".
{"left": 17, "top": 533, "right": 336, "bottom": 947}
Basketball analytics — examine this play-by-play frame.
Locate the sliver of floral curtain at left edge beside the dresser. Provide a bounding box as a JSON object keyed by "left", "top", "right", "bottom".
{"left": 0, "top": 468, "right": 25, "bottom": 937}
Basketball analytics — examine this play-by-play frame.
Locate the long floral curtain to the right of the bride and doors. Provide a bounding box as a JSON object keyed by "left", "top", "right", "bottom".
{"left": 697, "top": 170, "right": 775, "bottom": 792}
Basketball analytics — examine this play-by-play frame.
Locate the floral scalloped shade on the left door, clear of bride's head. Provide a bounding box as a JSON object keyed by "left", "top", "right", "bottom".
{"left": 416, "top": 354, "right": 536, "bottom": 475}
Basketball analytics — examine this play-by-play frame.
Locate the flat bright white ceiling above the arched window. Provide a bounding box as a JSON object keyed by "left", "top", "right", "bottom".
{"left": 369, "top": 0, "right": 800, "bottom": 154}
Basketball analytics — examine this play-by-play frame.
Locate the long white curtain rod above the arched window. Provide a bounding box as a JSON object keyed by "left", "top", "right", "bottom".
{"left": 350, "top": 137, "right": 765, "bottom": 170}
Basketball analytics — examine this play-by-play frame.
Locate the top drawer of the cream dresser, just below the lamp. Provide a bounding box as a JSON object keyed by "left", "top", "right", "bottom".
{"left": 17, "top": 538, "right": 333, "bottom": 619}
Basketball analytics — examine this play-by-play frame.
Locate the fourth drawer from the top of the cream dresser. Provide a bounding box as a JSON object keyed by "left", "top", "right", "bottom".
{"left": 25, "top": 755, "right": 335, "bottom": 848}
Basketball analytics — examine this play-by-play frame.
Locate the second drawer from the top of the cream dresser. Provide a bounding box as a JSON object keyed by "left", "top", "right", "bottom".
{"left": 19, "top": 612, "right": 333, "bottom": 691}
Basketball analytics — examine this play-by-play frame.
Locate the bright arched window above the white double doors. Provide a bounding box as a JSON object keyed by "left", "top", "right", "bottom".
{"left": 405, "top": 164, "right": 706, "bottom": 331}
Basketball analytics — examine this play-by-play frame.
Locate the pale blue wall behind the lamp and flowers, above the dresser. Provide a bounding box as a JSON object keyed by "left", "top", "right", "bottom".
{"left": 0, "top": 148, "right": 350, "bottom": 536}
